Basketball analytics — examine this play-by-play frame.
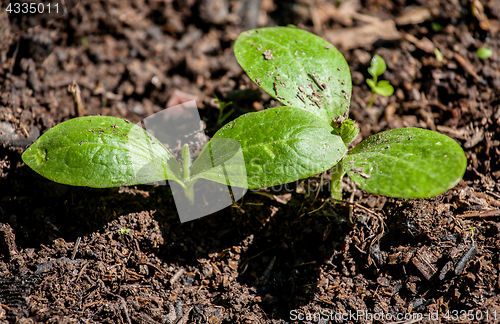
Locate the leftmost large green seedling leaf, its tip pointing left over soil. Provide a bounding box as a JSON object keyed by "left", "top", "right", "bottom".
{"left": 22, "top": 116, "right": 180, "bottom": 188}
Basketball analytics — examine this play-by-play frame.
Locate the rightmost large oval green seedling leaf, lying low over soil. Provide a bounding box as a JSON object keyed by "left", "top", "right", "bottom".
{"left": 344, "top": 128, "right": 467, "bottom": 198}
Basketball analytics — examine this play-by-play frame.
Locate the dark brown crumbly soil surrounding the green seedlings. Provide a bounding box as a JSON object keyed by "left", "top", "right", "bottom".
{"left": 0, "top": 0, "right": 500, "bottom": 324}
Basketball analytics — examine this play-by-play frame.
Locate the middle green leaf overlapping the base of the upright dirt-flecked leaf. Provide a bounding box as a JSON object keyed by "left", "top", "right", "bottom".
{"left": 191, "top": 107, "right": 347, "bottom": 189}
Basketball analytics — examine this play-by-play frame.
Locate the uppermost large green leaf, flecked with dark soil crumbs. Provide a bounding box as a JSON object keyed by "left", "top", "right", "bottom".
{"left": 234, "top": 27, "right": 352, "bottom": 123}
